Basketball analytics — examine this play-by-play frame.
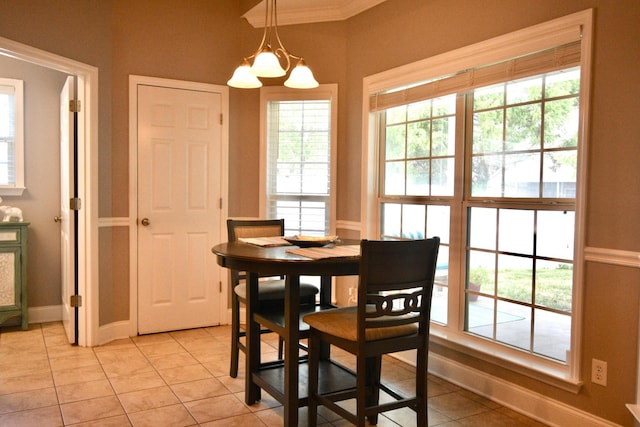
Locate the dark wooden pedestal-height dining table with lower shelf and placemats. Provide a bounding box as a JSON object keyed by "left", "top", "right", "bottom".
{"left": 211, "top": 239, "right": 360, "bottom": 427}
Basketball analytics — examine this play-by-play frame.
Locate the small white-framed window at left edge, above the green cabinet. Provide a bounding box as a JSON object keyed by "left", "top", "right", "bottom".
{"left": 0, "top": 78, "right": 24, "bottom": 196}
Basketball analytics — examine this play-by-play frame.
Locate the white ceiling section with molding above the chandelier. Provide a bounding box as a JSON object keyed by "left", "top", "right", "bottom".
{"left": 243, "top": 0, "right": 385, "bottom": 28}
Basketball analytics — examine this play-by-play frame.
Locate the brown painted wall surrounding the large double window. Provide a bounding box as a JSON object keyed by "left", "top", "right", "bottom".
{"left": 344, "top": 0, "right": 640, "bottom": 425}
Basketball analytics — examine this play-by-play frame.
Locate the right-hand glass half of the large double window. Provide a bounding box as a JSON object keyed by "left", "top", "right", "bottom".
{"left": 465, "top": 68, "right": 580, "bottom": 362}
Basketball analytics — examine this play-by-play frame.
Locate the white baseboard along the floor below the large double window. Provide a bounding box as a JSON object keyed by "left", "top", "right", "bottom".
{"left": 394, "top": 351, "right": 618, "bottom": 427}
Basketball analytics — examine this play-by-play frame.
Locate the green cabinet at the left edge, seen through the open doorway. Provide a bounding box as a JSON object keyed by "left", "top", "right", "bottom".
{"left": 0, "top": 222, "right": 29, "bottom": 330}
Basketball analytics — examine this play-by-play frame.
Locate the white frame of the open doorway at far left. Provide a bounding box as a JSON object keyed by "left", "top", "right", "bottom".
{"left": 0, "top": 37, "right": 99, "bottom": 346}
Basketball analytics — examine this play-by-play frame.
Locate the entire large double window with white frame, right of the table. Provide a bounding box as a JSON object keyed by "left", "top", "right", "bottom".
{"left": 363, "top": 13, "right": 590, "bottom": 387}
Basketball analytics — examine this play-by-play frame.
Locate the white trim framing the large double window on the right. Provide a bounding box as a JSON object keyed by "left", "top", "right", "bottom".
{"left": 360, "top": 9, "right": 593, "bottom": 393}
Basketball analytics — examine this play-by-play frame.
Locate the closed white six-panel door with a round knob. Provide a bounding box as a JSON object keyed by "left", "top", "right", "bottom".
{"left": 137, "top": 84, "right": 222, "bottom": 334}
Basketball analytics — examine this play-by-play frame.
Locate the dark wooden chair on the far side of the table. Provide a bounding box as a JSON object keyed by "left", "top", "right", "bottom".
{"left": 227, "top": 219, "right": 318, "bottom": 378}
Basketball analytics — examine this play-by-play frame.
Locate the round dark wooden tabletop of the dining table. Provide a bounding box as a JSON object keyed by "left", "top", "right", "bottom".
{"left": 211, "top": 241, "right": 360, "bottom": 276}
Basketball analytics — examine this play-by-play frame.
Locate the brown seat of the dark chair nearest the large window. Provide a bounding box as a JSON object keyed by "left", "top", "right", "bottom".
{"left": 302, "top": 306, "right": 418, "bottom": 341}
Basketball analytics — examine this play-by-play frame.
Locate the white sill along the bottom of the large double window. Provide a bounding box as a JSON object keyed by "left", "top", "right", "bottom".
{"left": 431, "top": 324, "right": 583, "bottom": 394}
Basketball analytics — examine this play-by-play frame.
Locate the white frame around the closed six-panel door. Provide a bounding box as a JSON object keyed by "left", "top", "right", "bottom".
{"left": 129, "top": 75, "right": 229, "bottom": 336}
